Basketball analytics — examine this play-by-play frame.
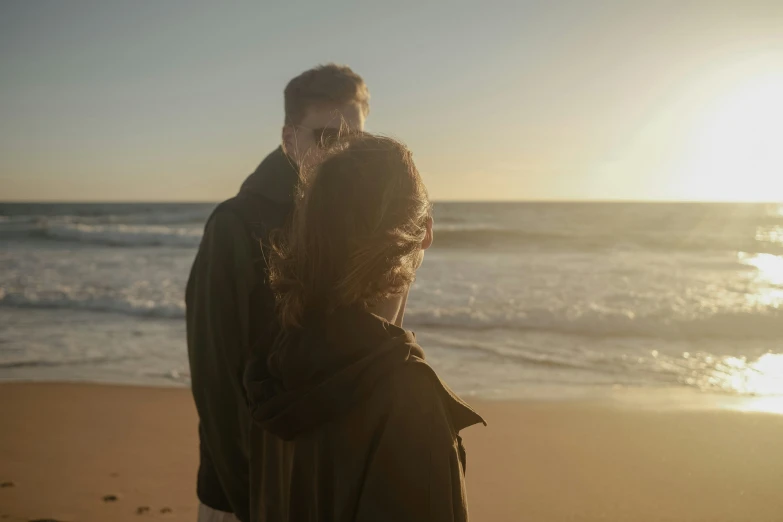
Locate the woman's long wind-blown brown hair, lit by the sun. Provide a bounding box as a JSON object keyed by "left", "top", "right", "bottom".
{"left": 269, "top": 134, "right": 431, "bottom": 329}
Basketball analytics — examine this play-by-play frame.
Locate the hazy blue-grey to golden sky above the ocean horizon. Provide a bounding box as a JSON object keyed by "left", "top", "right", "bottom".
{"left": 0, "top": 0, "right": 783, "bottom": 201}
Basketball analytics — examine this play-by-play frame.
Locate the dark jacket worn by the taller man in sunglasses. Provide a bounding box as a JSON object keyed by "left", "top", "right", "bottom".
{"left": 185, "top": 149, "right": 298, "bottom": 522}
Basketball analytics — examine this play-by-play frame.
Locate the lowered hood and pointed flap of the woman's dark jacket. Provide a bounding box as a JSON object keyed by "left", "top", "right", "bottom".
{"left": 245, "top": 309, "right": 484, "bottom": 440}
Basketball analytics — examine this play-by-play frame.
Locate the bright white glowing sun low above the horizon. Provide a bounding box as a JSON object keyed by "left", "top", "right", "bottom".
{"left": 677, "top": 72, "right": 783, "bottom": 201}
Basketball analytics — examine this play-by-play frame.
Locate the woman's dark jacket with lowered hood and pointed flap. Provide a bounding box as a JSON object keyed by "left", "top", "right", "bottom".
{"left": 245, "top": 309, "right": 483, "bottom": 522}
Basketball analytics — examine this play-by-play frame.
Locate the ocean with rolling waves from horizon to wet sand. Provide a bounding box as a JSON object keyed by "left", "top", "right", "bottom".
{"left": 0, "top": 203, "right": 783, "bottom": 398}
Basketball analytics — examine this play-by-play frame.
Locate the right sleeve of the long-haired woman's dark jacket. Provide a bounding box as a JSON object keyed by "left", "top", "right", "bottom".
{"left": 356, "top": 372, "right": 468, "bottom": 522}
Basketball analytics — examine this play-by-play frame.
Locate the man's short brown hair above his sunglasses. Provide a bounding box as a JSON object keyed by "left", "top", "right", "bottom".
{"left": 284, "top": 63, "right": 370, "bottom": 125}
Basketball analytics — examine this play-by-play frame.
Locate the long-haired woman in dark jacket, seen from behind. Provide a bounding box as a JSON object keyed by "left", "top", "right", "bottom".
{"left": 246, "top": 135, "right": 483, "bottom": 522}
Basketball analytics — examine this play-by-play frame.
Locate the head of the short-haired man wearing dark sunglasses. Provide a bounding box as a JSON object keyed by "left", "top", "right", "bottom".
{"left": 283, "top": 64, "right": 370, "bottom": 168}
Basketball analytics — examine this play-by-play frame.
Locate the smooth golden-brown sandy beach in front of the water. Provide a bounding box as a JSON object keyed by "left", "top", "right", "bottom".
{"left": 0, "top": 383, "right": 783, "bottom": 522}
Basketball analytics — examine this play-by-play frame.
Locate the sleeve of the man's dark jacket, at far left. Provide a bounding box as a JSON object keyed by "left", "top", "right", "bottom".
{"left": 186, "top": 209, "right": 257, "bottom": 520}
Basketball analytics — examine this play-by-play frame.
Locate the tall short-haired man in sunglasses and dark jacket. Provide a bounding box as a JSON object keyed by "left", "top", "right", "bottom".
{"left": 185, "top": 64, "right": 369, "bottom": 522}
